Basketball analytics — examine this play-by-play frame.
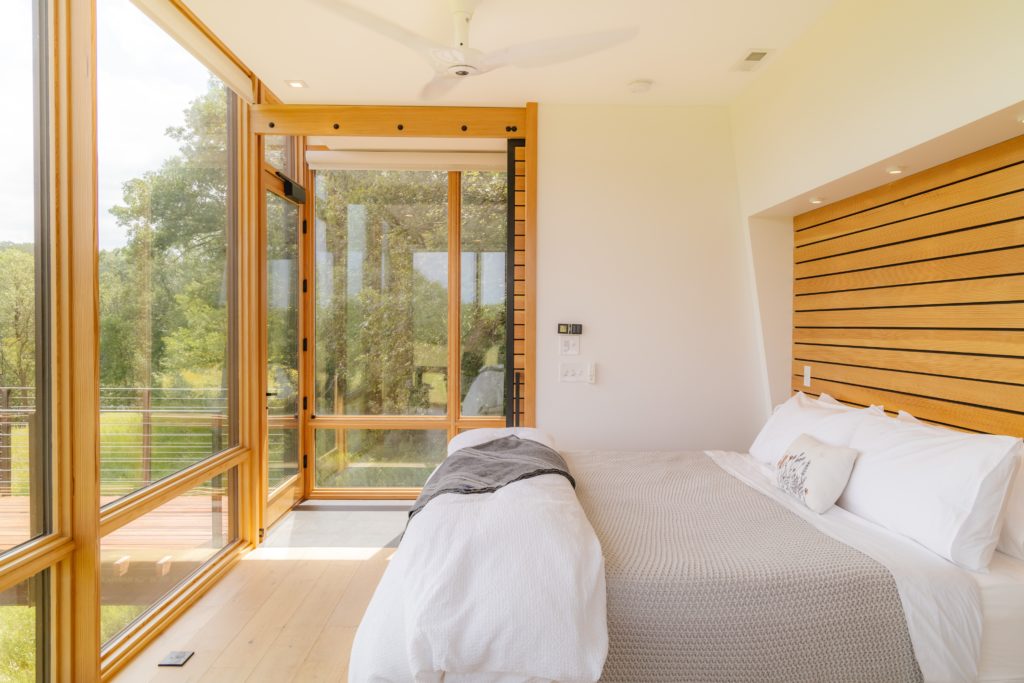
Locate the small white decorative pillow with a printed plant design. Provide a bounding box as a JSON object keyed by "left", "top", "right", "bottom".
{"left": 775, "top": 434, "right": 857, "bottom": 515}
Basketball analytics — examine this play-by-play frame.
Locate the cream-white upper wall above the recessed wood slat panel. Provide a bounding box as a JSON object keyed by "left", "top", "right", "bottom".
{"left": 731, "top": 0, "right": 1024, "bottom": 215}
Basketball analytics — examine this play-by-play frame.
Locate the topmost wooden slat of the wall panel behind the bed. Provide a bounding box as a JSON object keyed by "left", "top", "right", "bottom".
{"left": 793, "top": 137, "right": 1024, "bottom": 230}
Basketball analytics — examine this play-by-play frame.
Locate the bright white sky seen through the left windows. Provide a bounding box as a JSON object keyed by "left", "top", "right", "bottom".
{"left": 0, "top": 0, "right": 210, "bottom": 249}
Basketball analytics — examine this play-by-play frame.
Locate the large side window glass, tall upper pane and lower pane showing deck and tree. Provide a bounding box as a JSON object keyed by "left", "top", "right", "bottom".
{"left": 96, "top": 0, "right": 238, "bottom": 642}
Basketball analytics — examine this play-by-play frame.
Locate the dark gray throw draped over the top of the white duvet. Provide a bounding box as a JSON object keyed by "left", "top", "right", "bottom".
{"left": 409, "top": 436, "right": 575, "bottom": 519}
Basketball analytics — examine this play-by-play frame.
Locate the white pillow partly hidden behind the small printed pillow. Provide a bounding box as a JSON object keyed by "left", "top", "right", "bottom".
{"left": 751, "top": 391, "right": 884, "bottom": 467}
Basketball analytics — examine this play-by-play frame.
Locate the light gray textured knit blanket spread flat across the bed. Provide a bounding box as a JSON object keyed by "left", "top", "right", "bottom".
{"left": 566, "top": 453, "right": 922, "bottom": 683}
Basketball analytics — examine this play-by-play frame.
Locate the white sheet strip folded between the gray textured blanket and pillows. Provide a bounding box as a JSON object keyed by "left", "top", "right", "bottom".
{"left": 708, "top": 451, "right": 987, "bottom": 683}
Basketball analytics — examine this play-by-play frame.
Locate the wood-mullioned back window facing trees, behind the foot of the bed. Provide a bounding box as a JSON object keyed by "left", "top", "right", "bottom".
{"left": 312, "top": 170, "right": 508, "bottom": 496}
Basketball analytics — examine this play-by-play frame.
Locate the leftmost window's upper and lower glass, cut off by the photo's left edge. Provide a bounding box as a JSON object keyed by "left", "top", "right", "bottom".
{"left": 0, "top": 0, "right": 53, "bottom": 682}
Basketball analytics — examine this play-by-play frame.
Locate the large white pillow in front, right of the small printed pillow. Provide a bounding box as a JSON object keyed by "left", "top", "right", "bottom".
{"left": 839, "top": 417, "right": 1020, "bottom": 570}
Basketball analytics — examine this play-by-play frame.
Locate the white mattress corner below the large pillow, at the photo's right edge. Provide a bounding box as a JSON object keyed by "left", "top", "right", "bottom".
{"left": 971, "top": 553, "right": 1024, "bottom": 683}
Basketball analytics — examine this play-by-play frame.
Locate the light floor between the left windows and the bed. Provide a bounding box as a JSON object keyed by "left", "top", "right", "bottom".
{"left": 108, "top": 504, "right": 406, "bottom": 683}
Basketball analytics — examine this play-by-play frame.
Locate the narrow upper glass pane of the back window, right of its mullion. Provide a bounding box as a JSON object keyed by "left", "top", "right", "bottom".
{"left": 460, "top": 171, "right": 508, "bottom": 416}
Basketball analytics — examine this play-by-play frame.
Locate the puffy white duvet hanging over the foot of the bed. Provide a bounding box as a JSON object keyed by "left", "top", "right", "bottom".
{"left": 348, "top": 474, "right": 608, "bottom": 683}
